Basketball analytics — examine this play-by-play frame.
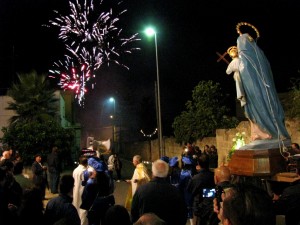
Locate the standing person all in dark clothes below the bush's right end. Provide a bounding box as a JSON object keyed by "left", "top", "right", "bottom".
{"left": 47, "top": 147, "right": 62, "bottom": 194}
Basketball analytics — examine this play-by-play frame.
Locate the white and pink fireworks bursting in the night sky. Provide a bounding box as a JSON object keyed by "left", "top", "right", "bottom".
{"left": 49, "top": 0, "right": 140, "bottom": 104}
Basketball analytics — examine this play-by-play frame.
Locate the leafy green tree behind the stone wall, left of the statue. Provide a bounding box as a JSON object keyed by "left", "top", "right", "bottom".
{"left": 172, "top": 80, "right": 239, "bottom": 143}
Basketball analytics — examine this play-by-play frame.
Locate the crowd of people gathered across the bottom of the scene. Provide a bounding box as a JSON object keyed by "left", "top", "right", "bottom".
{"left": 0, "top": 142, "right": 300, "bottom": 225}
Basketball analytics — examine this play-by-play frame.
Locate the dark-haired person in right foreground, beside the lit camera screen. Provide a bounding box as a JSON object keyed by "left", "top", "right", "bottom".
{"left": 214, "top": 182, "right": 276, "bottom": 225}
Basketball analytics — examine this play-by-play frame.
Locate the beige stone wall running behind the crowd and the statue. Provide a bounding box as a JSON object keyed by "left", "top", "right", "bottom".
{"left": 120, "top": 119, "right": 300, "bottom": 168}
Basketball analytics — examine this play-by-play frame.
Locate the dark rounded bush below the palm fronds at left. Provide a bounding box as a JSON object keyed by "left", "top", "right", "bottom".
{"left": 1, "top": 120, "right": 75, "bottom": 164}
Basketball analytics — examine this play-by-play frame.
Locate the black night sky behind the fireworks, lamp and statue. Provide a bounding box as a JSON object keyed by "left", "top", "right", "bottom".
{"left": 0, "top": 0, "right": 300, "bottom": 135}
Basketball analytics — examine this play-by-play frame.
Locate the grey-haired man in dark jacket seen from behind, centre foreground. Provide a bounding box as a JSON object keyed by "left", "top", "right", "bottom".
{"left": 131, "top": 159, "right": 187, "bottom": 225}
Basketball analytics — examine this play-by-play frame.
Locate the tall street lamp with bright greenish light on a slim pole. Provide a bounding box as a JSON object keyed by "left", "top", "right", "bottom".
{"left": 145, "top": 27, "right": 164, "bottom": 156}
